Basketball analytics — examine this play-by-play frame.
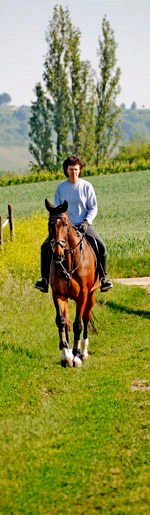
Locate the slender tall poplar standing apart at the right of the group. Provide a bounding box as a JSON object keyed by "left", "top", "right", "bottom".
{"left": 95, "top": 16, "right": 121, "bottom": 166}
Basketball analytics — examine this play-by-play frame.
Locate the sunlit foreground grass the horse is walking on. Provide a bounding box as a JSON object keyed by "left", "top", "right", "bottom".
{"left": 0, "top": 280, "right": 150, "bottom": 515}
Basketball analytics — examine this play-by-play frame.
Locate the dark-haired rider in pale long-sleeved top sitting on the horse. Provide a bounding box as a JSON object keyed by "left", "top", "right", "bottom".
{"left": 35, "top": 156, "right": 113, "bottom": 293}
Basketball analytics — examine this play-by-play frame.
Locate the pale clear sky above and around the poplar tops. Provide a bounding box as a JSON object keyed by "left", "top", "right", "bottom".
{"left": 0, "top": 0, "right": 150, "bottom": 109}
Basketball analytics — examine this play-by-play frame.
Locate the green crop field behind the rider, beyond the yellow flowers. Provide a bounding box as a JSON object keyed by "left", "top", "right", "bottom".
{"left": 0, "top": 171, "right": 150, "bottom": 277}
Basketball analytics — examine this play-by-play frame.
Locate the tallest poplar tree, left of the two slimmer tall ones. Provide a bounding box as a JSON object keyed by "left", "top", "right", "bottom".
{"left": 44, "top": 6, "right": 70, "bottom": 160}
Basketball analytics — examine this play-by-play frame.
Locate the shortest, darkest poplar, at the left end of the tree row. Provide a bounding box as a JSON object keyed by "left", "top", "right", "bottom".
{"left": 29, "top": 82, "right": 52, "bottom": 169}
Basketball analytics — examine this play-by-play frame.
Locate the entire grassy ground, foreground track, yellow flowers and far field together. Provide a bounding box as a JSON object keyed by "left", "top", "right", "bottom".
{"left": 0, "top": 172, "right": 150, "bottom": 515}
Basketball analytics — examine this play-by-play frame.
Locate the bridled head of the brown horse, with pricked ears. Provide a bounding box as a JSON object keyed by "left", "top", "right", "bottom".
{"left": 45, "top": 199, "right": 68, "bottom": 261}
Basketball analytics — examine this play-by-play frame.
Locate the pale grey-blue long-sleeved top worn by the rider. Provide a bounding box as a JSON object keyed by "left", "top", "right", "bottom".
{"left": 54, "top": 179, "right": 97, "bottom": 225}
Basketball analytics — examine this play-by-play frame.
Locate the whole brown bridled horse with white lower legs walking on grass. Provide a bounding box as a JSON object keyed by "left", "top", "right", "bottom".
{"left": 45, "top": 199, "right": 99, "bottom": 368}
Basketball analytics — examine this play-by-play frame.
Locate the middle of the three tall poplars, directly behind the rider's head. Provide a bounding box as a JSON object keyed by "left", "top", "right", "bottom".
{"left": 69, "top": 24, "right": 95, "bottom": 161}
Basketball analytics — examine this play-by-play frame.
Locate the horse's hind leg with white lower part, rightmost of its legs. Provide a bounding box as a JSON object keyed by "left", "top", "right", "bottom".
{"left": 81, "top": 292, "right": 95, "bottom": 359}
